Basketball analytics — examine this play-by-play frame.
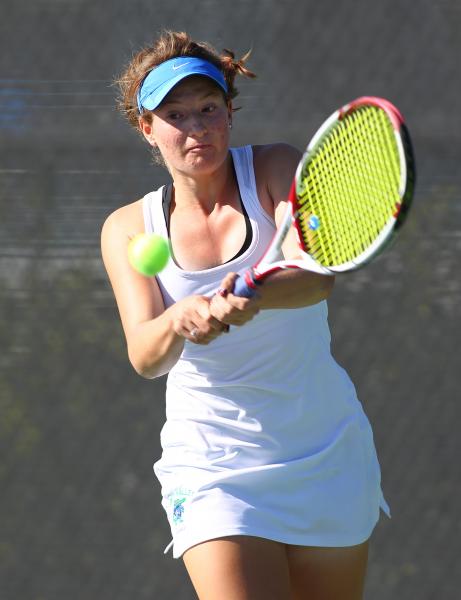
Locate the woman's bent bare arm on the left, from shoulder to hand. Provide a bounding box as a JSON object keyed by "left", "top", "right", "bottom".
{"left": 101, "top": 203, "right": 224, "bottom": 379}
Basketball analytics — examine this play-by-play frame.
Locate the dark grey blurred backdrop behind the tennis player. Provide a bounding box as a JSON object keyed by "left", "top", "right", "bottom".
{"left": 0, "top": 0, "right": 461, "bottom": 600}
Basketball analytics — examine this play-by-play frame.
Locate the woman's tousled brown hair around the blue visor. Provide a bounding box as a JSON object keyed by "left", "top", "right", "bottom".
{"left": 114, "top": 30, "right": 256, "bottom": 131}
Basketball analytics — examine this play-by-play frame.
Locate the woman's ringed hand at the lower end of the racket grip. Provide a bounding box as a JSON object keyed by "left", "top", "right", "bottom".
{"left": 170, "top": 295, "right": 229, "bottom": 345}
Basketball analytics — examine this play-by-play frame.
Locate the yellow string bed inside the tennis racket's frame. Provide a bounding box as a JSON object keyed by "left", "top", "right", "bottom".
{"left": 298, "top": 106, "right": 401, "bottom": 267}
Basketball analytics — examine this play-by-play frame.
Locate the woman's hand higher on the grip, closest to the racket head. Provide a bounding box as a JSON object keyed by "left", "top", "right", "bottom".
{"left": 210, "top": 273, "right": 260, "bottom": 326}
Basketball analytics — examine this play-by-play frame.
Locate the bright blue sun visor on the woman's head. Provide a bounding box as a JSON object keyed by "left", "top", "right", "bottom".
{"left": 138, "top": 56, "right": 227, "bottom": 113}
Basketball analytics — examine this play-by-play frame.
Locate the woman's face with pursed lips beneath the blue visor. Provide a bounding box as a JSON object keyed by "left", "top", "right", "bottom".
{"left": 141, "top": 76, "right": 231, "bottom": 176}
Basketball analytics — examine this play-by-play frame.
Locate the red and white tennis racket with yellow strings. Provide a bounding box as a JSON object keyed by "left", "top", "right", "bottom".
{"left": 233, "top": 96, "right": 415, "bottom": 298}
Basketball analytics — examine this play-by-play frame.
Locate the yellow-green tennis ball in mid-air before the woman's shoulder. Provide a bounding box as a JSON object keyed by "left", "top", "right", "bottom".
{"left": 128, "top": 233, "right": 170, "bottom": 277}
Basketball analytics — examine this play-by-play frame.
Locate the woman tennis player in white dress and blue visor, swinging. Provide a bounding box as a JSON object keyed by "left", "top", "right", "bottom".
{"left": 102, "top": 31, "right": 388, "bottom": 600}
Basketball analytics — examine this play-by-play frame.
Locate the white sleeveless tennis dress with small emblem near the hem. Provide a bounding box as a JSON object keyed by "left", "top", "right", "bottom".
{"left": 143, "top": 146, "right": 389, "bottom": 558}
